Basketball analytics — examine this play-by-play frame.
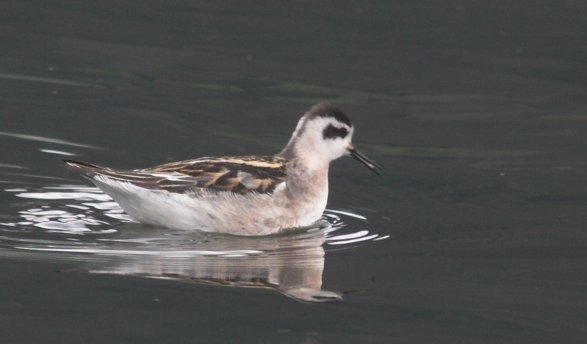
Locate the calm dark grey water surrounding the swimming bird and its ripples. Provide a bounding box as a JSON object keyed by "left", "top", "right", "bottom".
{"left": 0, "top": 1, "right": 587, "bottom": 343}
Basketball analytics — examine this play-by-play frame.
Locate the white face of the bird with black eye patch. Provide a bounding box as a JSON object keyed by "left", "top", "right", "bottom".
{"left": 296, "top": 117, "right": 353, "bottom": 162}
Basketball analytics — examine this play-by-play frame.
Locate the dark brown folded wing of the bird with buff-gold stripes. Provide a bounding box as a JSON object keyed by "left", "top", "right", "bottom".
{"left": 66, "top": 156, "right": 286, "bottom": 194}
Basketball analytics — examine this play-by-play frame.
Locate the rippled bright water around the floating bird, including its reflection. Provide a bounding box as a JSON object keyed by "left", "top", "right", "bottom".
{"left": 0, "top": 185, "right": 388, "bottom": 302}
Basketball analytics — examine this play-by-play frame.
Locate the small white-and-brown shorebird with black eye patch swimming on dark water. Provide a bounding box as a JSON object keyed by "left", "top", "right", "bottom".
{"left": 64, "top": 103, "right": 383, "bottom": 236}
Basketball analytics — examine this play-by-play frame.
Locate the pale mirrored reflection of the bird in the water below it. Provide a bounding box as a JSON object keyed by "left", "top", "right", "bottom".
{"left": 76, "top": 224, "right": 342, "bottom": 302}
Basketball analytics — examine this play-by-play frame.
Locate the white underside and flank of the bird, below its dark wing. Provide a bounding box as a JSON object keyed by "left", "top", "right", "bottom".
{"left": 92, "top": 176, "right": 327, "bottom": 235}
